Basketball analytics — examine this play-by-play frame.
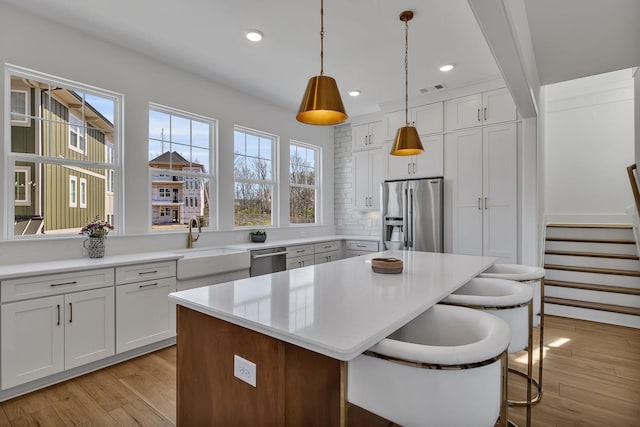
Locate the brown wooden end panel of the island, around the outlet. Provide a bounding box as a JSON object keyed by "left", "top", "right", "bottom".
{"left": 177, "top": 306, "right": 356, "bottom": 427}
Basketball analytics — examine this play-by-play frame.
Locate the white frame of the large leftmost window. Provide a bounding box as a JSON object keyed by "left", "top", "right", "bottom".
{"left": 0, "top": 63, "right": 125, "bottom": 240}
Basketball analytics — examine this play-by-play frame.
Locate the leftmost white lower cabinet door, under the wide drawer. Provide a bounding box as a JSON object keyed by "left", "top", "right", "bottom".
{"left": 2, "top": 296, "right": 64, "bottom": 389}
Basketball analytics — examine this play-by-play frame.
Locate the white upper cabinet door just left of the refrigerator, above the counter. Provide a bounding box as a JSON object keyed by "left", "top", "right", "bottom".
{"left": 353, "top": 148, "right": 385, "bottom": 210}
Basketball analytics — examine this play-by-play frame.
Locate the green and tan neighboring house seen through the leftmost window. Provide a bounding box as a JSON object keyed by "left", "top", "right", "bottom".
{"left": 11, "top": 78, "right": 113, "bottom": 235}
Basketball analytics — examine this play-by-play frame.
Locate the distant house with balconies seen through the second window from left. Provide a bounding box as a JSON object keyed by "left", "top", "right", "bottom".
{"left": 149, "top": 151, "right": 209, "bottom": 225}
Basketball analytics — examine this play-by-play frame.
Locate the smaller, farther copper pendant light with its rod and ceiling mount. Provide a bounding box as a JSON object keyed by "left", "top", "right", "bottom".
{"left": 391, "top": 10, "right": 424, "bottom": 156}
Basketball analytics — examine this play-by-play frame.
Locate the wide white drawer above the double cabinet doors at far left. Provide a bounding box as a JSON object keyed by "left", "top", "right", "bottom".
{"left": 2, "top": 268, "right": 114, "bottom": 303}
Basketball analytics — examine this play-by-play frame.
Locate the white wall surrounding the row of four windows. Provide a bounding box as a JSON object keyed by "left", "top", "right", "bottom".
{"left": 0, "top": 3, "right": 335, "bottom": 264}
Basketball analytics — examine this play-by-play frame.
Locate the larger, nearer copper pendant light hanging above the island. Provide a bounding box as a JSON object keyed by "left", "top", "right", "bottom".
{"left": 296, "top": 0, "right": 348, "bottom": 125}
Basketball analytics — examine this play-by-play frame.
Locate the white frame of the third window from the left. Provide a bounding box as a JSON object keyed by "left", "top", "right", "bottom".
{"left": 232, "top": 125, "right": 280, "bottom": 230}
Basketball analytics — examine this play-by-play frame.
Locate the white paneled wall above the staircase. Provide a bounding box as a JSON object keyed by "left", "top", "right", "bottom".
{"left": 541, "top": 70, "right": 634, "bottom": 223}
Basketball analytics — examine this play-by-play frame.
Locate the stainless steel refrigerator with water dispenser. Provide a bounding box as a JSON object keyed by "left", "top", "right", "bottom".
{"left": 381, "top": 178, "right": 444, "bottom": 252}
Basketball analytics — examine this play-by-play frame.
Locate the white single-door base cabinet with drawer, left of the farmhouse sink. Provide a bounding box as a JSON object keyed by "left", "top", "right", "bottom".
{"left": 116, "top": 261, "right": 176, "bottom": 353}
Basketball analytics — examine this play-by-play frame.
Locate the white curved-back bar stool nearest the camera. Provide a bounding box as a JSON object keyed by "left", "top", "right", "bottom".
{"left": 347, "top": 305, "right": 511, "bottom": 427}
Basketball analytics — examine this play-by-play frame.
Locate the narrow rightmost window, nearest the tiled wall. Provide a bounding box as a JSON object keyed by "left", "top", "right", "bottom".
{"left": 289, "top": 141, "right": 320, "bottom": 224}
